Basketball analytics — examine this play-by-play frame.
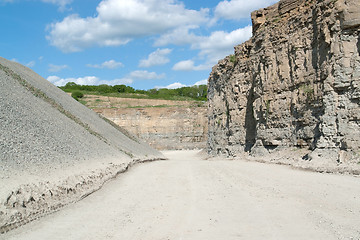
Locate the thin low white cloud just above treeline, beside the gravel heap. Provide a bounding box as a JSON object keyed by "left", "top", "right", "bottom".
{"left": 47, "top": 76, "right": 133, "bottom": 86}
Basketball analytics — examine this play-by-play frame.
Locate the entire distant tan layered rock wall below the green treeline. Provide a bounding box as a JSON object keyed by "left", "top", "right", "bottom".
{"left": 84, "top": 96, "right": 207, "bottom": 150}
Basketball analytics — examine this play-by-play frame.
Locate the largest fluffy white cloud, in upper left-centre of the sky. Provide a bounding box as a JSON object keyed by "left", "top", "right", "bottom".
{"left": 47, "top": 0, "right": 209, "bottom": 52}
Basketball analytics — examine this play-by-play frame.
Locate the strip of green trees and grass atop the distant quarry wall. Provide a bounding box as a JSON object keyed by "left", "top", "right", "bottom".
{"left": 60, "top": 82, "right": 207, "bottom": 101}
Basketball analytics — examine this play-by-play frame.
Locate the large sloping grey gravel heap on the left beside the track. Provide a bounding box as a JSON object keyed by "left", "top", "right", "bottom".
{"left": 0, "top": 58, "right": 164, "bottom": 233}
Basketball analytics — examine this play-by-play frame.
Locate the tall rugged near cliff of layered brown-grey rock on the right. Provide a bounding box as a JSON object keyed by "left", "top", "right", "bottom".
{"left": 208, "top": 0, "right": 360, "bottom": 162}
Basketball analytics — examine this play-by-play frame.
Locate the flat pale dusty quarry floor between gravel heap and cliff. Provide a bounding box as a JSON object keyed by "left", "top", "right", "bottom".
{"left": 0, "top": 151, "right": 360, "bottom": 240}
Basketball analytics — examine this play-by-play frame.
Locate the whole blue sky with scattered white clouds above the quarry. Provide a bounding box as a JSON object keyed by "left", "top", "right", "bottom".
{"left": 0, "top": 0, "right": 277, "bottom": 89}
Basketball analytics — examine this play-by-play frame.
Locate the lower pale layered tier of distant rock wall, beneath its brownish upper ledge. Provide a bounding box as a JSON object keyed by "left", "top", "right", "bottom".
{"left": 94, "top": 106, "right": 207, "bottom": 150}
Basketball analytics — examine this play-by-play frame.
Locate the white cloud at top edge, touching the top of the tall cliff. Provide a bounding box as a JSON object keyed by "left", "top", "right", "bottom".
{"left": 215, "top": 0, "right": 278, "bottom": 20}
